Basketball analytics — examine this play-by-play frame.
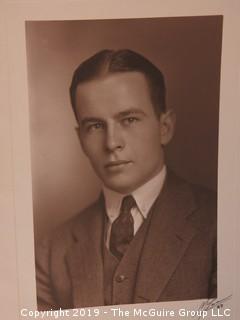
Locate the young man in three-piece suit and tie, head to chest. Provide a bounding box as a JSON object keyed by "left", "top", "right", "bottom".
{"left": 36, "top": 50, "right": 217, "bottom": 310}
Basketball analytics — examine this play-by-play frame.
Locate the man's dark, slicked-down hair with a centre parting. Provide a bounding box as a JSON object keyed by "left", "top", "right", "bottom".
{"left": 70, "top": 49, "right": 166, "bottom": 120}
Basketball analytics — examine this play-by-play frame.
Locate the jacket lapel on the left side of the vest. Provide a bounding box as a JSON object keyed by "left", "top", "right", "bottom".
{"left": 67, "top": 196, "right": 104, "bottom": 307}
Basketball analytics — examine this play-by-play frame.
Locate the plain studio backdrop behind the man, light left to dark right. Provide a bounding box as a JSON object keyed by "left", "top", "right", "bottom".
{"left": 26, "top": 16, "right": 222, "bottom": 240}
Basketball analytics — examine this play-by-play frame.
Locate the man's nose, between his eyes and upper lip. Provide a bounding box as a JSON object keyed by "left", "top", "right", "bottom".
{"left": 106, "top": 126, "right": 125, "bottom": 152}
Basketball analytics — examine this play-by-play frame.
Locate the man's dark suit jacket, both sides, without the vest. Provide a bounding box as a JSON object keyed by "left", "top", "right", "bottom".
{"left": 36, "top": 172, "right": 217, "bottom": 310}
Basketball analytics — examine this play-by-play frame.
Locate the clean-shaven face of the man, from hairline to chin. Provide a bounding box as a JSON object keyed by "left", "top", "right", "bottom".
{"left": 76, "top": 72, "right": 169, "bottom": 194}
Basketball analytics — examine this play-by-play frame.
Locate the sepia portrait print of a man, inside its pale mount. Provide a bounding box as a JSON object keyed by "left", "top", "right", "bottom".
{"left": 25, "top": 15, "right": 223, "bottom": 310}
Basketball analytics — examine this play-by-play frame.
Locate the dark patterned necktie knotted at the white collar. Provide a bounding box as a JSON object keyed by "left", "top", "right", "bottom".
{"left": 109, "top": 195, "right": 136, "bottom": 260}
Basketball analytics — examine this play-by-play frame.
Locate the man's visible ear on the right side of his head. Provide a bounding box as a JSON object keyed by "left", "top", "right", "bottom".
{"left": 160, "top": 109, "right": 176, "bottom": 145}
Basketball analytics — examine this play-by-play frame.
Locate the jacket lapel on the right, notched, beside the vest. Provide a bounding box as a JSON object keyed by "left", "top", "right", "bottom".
{"left": 134, "top": 173, "right": 196, "bottom": 303}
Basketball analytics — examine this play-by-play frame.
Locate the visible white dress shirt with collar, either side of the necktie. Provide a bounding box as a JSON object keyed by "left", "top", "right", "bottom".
{"left": 103, "top": 165, "right": 166, "bottom": 248}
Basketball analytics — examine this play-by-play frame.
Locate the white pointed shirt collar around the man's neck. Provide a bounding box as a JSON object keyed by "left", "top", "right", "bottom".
{"left": 103, "top": 165, "right": 166, "bottom": 222}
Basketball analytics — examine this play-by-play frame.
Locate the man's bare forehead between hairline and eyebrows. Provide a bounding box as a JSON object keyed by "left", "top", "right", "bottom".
{"left": 76, "top": 72, "right": 153, "bottom": 118}
